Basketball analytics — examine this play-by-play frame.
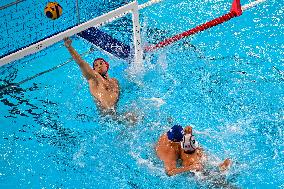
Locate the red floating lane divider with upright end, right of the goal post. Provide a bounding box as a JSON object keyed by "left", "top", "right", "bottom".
{"left": 144, "top": 0, "right": 242, "bottom": 52}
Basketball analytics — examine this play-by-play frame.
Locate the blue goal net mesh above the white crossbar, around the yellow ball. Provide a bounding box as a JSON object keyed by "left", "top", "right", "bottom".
{"left": 0, "top": 0, "right": 133, "bottom": 57}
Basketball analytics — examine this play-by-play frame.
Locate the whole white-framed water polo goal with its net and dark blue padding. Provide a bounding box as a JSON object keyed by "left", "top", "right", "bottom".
{"left": 0, "top": 0, "right": 142, "bottom": 66}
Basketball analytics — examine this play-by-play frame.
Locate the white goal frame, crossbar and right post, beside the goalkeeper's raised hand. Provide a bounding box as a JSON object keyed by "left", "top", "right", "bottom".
{"left": 0, "top": 1, "right": 143, "bottom": 67}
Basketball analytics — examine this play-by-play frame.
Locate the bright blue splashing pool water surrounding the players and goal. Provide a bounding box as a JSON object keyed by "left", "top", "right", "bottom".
{"left": 0, "top": 0, "right": 284, "bottom": 188}
